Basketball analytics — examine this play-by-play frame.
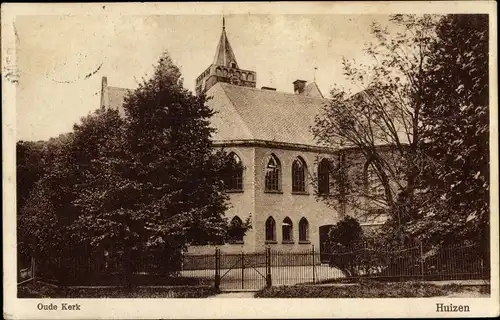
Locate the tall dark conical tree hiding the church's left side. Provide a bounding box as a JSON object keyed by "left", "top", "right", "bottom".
{"left": 73, "top": 54, "right": 238, "bottom": 285}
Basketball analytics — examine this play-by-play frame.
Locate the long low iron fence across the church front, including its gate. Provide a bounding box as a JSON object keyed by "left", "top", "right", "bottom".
{"left": 24, "top": 244, "right": 489, "bottom": 289}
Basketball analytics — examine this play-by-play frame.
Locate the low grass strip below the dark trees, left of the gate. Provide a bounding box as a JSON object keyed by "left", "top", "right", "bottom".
{"left": 17, "top": 282, "right": 218, "bottom": 298}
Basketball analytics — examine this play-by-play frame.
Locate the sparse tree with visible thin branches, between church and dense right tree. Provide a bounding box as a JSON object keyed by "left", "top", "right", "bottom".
{"left": 313, "top": 15, "right": 436, "bottom": 231}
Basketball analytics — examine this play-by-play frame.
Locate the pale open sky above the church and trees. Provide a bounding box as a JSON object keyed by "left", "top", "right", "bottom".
{"left": 15, "top": 14, "right": 389, "bottom": 140}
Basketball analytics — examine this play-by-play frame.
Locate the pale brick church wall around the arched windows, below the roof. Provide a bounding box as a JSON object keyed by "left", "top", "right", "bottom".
{"left": 189, "top": 146, "right": 396, "bottom": 254}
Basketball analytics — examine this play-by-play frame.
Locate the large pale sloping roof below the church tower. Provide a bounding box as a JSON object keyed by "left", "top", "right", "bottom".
{"left": 207, "top": 83, "right": 328, "bottom": 146}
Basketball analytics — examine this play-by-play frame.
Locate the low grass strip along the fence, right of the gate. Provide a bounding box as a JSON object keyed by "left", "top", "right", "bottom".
{"left": 255, "top": 281, "right": 490, "bottom": 298}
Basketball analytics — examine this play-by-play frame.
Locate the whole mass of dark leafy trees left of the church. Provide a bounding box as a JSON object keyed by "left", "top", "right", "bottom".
{"left": 19, "top": 54, "right": 245, "bottom": 284}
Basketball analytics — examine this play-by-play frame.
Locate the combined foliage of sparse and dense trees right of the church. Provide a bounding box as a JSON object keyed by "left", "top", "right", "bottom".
{"left": 313, "top": 15, "right": 489, "bottom": 268}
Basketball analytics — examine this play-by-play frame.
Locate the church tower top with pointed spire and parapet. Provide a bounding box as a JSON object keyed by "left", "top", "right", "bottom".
{"left": 196, "top": 17, "right": 257, "bottom": 95}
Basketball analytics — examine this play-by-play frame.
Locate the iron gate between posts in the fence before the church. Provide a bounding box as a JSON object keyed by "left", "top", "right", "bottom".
{"left": 215, "top": 249, "right": 271, "bottom": 291}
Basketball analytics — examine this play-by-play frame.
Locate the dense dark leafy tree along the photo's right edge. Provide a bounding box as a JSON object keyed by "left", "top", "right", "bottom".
{"left": 407, "top": 15, "right": 489, "bottom": 250}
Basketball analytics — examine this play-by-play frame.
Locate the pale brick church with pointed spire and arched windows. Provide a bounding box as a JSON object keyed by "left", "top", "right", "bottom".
{"left": 101, "top": 19, "right": 384, "bottom": 253}
